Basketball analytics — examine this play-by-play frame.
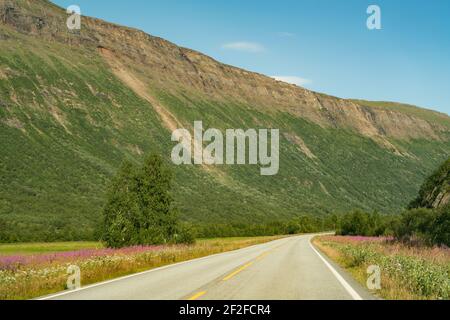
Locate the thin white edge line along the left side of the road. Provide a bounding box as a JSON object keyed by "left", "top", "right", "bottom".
{"left": 36, "top": 238, "right": 289, "bottom": 301}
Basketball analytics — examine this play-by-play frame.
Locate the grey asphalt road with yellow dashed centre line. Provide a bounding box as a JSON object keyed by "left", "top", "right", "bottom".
{"left": 42, "top": 235, "right": 372, "bottom": 300}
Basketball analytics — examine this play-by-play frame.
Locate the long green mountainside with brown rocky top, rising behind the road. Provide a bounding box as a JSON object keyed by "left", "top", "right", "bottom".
{"left": 0, "top": 0, "right": 450, "bottom": 240}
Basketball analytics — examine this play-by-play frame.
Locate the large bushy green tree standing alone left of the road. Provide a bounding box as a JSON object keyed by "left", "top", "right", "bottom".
{"left": 102, "top": 155, "right": 179, "bottom": 248}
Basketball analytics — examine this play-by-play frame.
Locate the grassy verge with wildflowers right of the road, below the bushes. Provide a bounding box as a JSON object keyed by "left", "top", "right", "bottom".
{"left": 314, "top": 236, "right": 450, "bottom": 300}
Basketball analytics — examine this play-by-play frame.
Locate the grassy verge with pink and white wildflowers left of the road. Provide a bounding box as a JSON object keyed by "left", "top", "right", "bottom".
{"left": 0, "top": 237, "right": 281, "bottom": 300}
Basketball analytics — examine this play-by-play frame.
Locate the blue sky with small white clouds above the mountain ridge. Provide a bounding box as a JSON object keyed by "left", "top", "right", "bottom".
{"left": 53, "top": 0, "right": 450, "bottom": 114}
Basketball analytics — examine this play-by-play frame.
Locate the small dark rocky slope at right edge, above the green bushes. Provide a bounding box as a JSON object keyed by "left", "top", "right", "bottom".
{"left": 410, "top": 159, "right": 450, "bottom": 208}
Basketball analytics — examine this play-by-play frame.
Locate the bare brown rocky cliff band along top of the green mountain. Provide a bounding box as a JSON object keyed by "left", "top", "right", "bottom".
{"left": 0, "top": 0, "right": 450, "bottom": 147}
